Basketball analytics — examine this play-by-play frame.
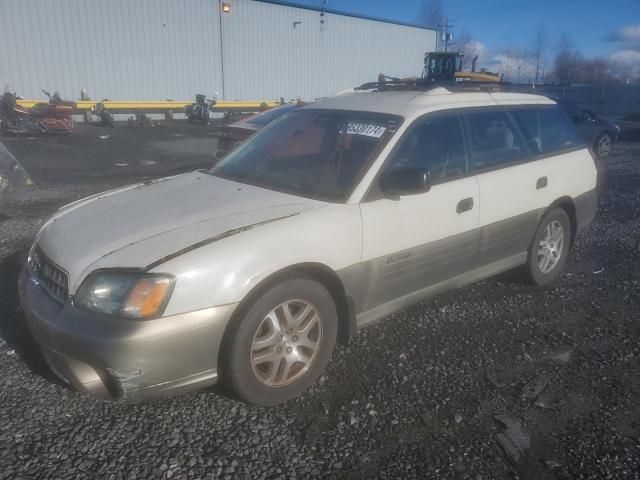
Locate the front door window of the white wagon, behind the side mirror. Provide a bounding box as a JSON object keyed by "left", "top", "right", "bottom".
{"left": 389, "top": 115, "right": 467, "bottom": 185}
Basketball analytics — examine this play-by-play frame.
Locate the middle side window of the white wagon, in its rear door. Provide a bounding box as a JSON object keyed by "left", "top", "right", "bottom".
{"left": 465, "top": 110, "right": 528, "bottom": 170}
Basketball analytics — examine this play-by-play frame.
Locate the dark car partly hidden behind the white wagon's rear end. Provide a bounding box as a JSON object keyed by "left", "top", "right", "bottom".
{"left": 556, "top": 100, "right": 620, "bottom": 158}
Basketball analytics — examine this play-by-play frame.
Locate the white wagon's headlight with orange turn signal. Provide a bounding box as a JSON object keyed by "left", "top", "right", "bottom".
{"left": 74, "top": 271, "right": 175, "bottom": 319}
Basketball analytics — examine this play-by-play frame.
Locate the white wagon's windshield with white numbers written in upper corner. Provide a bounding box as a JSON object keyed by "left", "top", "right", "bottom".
{"left": 209, "top": 109, "right": 400, "bottom": 202}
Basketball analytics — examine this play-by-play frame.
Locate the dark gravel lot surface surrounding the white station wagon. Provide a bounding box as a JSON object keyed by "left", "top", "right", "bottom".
{"left": 0, "top": 122, "right": 640, "bottom": 479}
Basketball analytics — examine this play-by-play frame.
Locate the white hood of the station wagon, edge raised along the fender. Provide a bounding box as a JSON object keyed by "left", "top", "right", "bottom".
{"left": 36, "top": 172, "right": 326, "bottom": 292}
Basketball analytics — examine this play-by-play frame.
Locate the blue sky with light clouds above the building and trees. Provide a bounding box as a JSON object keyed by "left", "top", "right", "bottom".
{"left": 290, "top": 0, "right": 640, "bottom": 78}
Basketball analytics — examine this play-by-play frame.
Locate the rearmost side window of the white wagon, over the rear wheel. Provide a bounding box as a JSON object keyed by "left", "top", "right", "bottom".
{"left": 511, "top": 107, "right": 583, "bottom": 154}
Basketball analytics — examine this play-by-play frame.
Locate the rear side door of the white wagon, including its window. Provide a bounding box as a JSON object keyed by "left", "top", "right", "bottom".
{"left": 464, "top": 108, "right": 550, "bottom": 266}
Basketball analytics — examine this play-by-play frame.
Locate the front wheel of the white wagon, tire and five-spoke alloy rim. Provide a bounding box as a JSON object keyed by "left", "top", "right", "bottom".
{"left": 220, "top": 275, "right": 338, "bottom": 406}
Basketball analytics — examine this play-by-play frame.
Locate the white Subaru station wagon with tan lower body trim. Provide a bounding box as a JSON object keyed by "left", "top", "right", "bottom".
{"left": 20, "top": 87, "right": 597, "bottom": 405}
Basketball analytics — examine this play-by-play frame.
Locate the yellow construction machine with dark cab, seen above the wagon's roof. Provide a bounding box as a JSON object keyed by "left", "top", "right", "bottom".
{"left": 422, "top": 52, "right": 502, "bottom": 83}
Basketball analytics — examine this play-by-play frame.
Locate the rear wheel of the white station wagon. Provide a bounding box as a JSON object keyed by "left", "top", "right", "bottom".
{"left": 525, "top": 208, "right": 571, "bottom": 285}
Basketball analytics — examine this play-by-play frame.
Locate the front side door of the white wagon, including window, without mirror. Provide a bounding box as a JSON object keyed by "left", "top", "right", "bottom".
{"left": 359, "top": 113, "right": 479, "bottom": 311}
